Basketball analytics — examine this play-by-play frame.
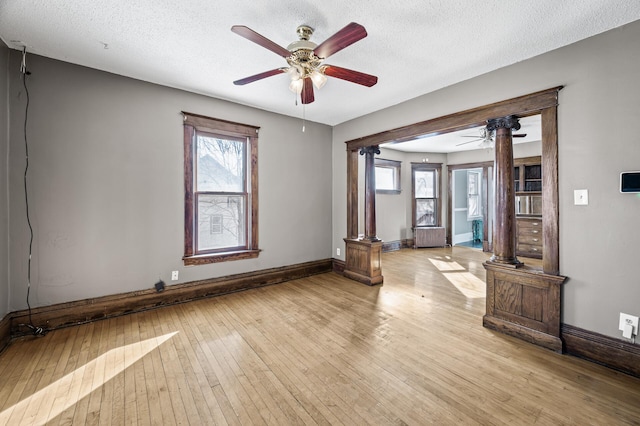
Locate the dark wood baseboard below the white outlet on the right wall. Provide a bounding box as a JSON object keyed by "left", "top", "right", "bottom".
{"left": 561, "top": 324, "right": 640, "bottom": 377}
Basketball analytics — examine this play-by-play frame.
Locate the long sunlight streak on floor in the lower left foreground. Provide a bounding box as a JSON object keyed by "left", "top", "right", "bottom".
{"left": 0, "top": 331, "right": 178, "bottom": 425}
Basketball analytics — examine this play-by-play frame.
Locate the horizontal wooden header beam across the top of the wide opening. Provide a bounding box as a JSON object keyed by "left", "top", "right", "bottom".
{"left": 345, "top": 86, "right": 562, "bottom": 150}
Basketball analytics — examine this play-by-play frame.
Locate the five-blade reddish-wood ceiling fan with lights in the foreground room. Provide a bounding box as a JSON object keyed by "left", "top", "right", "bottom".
{"left": 231, "top": 22, "right": 378, "bottom": 104}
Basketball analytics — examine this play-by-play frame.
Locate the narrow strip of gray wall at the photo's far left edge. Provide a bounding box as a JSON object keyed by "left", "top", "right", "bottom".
{"left": 0, "top": 41, "right": 9, "bottom": 319}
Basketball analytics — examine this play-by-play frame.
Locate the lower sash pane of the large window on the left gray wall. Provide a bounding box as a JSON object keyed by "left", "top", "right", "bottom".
{"left": 197, "top": 194, "right": 246, "bottom": 252}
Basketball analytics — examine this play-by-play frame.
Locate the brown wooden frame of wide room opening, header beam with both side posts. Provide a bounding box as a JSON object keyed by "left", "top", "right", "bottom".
{"left": 345, "top": 86, "right": 562, "bottom": 275}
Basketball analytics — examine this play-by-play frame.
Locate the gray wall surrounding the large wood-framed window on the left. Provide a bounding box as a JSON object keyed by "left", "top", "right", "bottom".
{"left": 6, "top": 55, "right": 332, "bottom": 310}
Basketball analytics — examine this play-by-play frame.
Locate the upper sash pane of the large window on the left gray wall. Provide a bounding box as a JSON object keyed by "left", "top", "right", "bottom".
{"left": 196, "top": 134, "right": 246, "bottom": 192}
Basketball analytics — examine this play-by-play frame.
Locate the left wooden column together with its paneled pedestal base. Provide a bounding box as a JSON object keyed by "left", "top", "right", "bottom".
{"left": 344, "top": 145, "right": 383, "bottom": 285}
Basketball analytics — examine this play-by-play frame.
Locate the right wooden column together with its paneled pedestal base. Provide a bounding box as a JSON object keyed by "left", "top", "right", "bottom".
{"left": 482, "top": 116, "right": 566, "bottom": 352}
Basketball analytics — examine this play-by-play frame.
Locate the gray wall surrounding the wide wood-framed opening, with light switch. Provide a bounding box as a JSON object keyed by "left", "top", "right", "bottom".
{"left": 333, "top": 21, "right": 640, "bottom": 337}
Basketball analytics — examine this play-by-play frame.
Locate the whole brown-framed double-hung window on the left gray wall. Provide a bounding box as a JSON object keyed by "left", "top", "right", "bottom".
{"left": 183, "top": 112, "right": 259, "bottom": 265}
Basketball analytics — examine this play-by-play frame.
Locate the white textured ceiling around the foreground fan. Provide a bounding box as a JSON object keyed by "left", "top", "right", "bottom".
{"left": 0, "top": 0, "right": 640, "bottom": 125}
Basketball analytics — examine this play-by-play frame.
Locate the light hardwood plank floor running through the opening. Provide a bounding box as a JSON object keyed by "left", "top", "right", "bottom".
{"left": 0, "top": 247, "right": 640, "bottom": 425}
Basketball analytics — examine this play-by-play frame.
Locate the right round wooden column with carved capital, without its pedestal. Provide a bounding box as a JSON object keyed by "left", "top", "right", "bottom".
{"left": 487, "top": 115, "right": 522, "bottom": 268}
